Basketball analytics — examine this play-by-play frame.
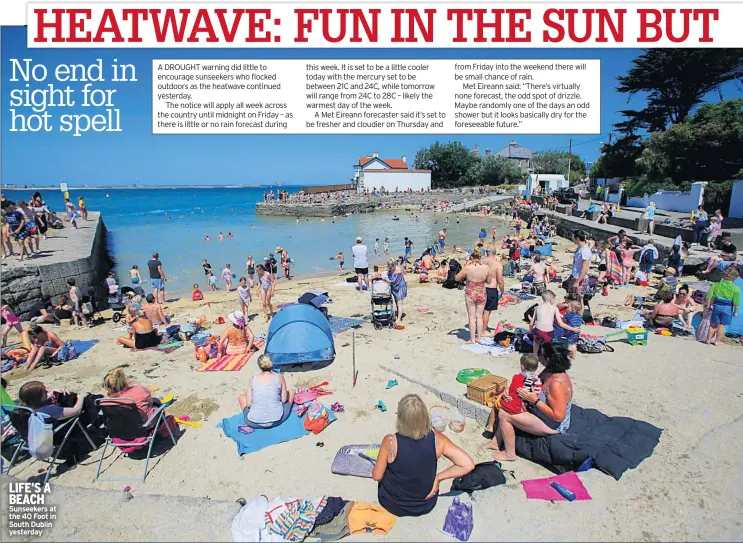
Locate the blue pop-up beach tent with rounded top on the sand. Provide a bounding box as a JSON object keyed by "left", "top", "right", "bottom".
{"left": 265, "top": 304, "right": 335, "bottom": 366}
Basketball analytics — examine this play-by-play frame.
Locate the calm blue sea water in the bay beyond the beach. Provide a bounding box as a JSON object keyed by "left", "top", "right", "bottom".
{"left": 7, "top": 187, "right": 506, "bottom": 292}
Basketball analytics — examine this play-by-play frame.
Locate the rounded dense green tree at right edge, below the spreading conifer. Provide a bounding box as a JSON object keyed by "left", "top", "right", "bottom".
{"left": 637, "top": 99, "right": 743, "bottom": 185}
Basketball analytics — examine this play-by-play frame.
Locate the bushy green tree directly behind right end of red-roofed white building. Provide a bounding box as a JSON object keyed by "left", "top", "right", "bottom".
{"left": 413, "top": 141, "right": 478, "bottom": 188}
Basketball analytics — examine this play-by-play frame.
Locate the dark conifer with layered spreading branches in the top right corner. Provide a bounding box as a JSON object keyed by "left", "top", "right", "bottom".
{"left": 615, "top": 49, "right": 743, "bottom": 135}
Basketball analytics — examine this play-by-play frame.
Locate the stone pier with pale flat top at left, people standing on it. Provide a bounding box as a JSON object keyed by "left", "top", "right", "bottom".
{"left": 0, "top": 211, "right": 113, "bottom": 319}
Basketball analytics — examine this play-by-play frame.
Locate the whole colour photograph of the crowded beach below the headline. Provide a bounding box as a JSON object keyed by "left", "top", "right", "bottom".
{"left": 0, "top": 21, "right": 743, "bottom": 541}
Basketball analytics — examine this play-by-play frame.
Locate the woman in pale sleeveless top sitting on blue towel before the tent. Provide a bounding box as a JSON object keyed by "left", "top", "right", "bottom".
{"left": 237, "top": 354, "right": 295, "bottom": 428}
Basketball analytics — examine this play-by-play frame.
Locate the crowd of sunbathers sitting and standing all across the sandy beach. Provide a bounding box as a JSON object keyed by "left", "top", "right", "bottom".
{"left": 2, "top": 190, "right": 741, "bottom": 532}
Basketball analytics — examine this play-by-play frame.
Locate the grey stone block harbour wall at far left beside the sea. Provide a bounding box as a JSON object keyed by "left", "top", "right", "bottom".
{"left": 0, "top": 217, "right": 113, "bottom": 320}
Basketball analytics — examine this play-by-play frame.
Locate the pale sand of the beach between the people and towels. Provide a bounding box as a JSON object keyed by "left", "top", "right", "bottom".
{"left": 3, "top": 236, "right": 743, "bottom": 541}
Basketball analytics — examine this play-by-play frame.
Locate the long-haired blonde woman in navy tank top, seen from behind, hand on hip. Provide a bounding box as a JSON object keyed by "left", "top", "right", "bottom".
{"left": 372, "top": 394, "right": 475, "bottom": 517}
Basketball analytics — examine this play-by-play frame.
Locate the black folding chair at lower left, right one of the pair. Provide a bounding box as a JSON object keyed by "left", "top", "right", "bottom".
{"left": 95, "top": 398, "right": 175, "bottom": 481}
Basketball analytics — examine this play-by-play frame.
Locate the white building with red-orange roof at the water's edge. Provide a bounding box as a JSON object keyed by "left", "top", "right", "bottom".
{"left": 352, "top": 153, "right": 431, "bottom": 192}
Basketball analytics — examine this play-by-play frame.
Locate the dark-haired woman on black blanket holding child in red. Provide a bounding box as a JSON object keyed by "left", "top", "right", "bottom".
{"left": 483, "top": 343, "right": 573, "bottom": 462}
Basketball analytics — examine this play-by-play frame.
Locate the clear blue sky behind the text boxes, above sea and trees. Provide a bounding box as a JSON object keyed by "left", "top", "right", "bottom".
{"left": 0, "top": 27, "right": 743, "bottom": 185}
